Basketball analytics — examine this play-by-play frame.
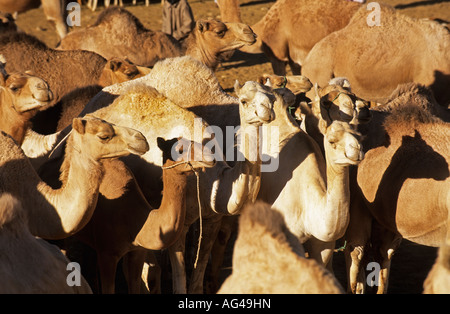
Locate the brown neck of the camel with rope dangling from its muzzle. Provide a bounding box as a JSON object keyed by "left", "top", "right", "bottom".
{"left": 135, "top": 162, "right": 187, "bottom": 250}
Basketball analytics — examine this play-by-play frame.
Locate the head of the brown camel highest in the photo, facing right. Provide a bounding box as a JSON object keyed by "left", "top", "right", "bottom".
{"left": 196, "top": 20, "right": 256, "bottom": 54}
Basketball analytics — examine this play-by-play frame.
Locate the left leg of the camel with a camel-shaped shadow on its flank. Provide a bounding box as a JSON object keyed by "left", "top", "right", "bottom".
{"left": 344, "top": 191, "right": 372, "bottom": 294}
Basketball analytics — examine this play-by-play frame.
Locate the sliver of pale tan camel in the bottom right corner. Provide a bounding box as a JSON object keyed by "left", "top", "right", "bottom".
{"left": 423, "top": 240, "right": 450, "bottom": 294}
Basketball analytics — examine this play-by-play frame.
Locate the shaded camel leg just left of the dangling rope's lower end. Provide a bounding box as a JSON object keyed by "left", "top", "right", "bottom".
{"left": 168, "top": 225, "right": 189, "bottom": 294}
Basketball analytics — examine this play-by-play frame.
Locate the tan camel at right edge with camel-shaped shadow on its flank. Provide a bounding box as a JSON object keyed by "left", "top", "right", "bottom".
{"left": 345, "top": 84, "right": 450, "bottom": 293}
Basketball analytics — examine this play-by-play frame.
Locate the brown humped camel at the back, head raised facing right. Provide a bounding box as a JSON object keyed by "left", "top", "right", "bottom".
{"left": 58, "top": 7, "right": 255, "bottom": 68}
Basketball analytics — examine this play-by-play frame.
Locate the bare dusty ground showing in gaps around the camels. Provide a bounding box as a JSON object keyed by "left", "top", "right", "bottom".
{"left": 12, "top": 0, "right": 450, "bottom": 293}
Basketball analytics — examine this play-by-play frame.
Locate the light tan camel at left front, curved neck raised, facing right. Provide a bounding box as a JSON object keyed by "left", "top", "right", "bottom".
{"left": 0, "top": 118, "right": 148, "bottom": 239}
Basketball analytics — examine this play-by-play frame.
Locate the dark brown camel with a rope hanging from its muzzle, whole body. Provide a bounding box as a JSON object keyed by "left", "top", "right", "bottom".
{"left": 57, "top": 138, "right": 215, "bottom": 293}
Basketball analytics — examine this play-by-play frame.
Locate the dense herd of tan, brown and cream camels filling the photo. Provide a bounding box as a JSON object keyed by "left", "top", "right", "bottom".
{"left": 0, "top": 0, "right": 450, "bottom": 294}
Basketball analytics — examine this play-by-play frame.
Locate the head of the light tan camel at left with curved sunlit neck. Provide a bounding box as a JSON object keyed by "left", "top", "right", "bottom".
{"left": 72, "top": 115, "right": 149, "bottom": 161}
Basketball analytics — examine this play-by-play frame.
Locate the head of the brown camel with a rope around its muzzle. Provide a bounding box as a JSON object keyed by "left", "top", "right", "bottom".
{"left": 157, "top": 137, "right": 216, "bottom": 173}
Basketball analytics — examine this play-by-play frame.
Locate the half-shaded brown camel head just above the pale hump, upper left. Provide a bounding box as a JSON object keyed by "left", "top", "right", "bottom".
{"left": 99, "top": 58, "right": 150, "bottom": 86}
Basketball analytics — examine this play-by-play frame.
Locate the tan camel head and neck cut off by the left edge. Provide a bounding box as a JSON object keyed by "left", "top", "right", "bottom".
{"left": 0, "top": 55, "right": 53, "bottom": 145}
